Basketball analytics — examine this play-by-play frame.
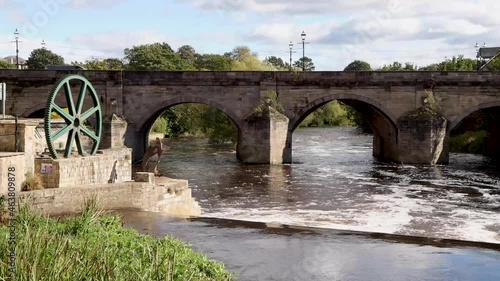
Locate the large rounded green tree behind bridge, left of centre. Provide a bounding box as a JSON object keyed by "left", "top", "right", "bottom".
{"left": 124, "top": 43, "right": 193, "bottom": 70}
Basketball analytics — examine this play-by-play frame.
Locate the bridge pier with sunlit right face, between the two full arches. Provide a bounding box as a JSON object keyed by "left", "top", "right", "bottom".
{"left": 236, "top": 106, "right": 291, "bottom": 164}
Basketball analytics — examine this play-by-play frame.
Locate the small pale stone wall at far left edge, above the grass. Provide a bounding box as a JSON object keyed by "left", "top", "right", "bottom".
{"left": 0, "top": 152, "right": 26, "bottom": 195}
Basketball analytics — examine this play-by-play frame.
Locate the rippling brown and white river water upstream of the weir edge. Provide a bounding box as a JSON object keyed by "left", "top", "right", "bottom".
{"left": 159, "top": 127, "right": 500, "bottom": 243}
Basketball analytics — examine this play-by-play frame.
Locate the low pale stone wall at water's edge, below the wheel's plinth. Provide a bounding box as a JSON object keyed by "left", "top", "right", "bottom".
{"left": 19, "top": 174, "right": 201, "bottom": 216}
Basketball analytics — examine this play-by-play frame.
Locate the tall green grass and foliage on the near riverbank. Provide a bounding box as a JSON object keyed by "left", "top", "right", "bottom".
{"left": 0, "top": 205, "right": 234, "bottom": 281}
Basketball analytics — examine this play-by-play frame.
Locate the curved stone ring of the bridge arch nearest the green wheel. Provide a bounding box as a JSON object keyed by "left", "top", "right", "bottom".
{"left": 137, "top": 97, "right": 242, "bottom": 132}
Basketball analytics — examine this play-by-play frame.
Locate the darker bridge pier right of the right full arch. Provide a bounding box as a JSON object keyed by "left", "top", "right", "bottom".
{"left": 396, "top": 108, "right": 449, "bottom": 165}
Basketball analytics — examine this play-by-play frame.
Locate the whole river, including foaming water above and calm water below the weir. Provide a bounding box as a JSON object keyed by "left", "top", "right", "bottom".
{"left": 122, "top": 127, "right": 500, "bottom": 281}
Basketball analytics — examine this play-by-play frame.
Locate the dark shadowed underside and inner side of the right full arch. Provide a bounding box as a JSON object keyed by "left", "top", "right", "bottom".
{"left": 287, "top": 93, "right": 398, "bottom": 161}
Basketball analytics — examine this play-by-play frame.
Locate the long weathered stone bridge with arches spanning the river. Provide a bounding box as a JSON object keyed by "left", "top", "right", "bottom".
{"left": 0, "top": 70, "right": 500, "bottom": 164}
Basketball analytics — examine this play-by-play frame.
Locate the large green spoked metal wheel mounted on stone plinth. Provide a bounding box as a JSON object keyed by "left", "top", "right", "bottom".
{"left": 44, "top": 75, "right": 102, "bottom": 159}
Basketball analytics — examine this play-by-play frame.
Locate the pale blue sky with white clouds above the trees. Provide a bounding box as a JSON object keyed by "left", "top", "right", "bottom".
{"left": 0, "top": 0, "right": 500, "bottom": 71}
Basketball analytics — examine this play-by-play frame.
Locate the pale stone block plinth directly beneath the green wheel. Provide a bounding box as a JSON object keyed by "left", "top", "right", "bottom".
{"left": 35, "top": 147, "right": 132, "bottom": 188}
